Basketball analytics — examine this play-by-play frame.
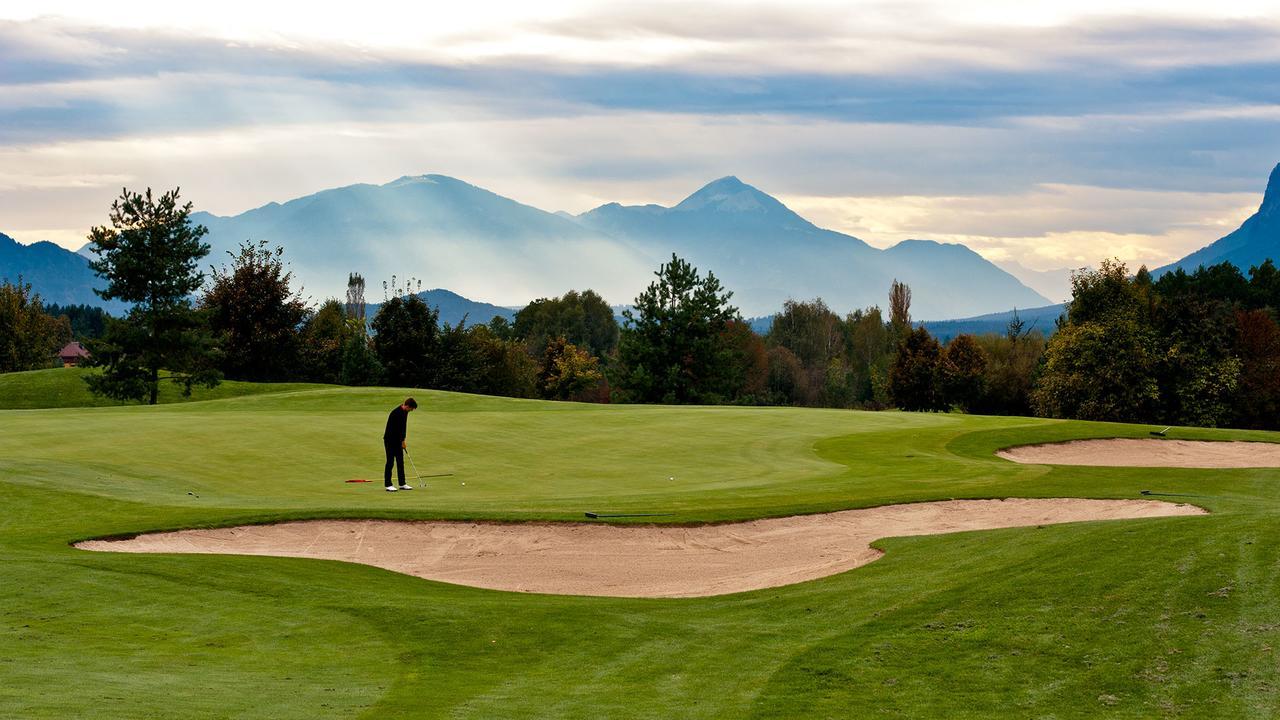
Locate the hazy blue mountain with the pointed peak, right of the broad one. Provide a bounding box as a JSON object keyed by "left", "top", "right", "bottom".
{"left": 577, "top": 177, "right": 1048, "bottom": 316}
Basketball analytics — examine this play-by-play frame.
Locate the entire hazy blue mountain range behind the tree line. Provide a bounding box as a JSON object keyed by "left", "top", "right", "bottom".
{"left": 0, "top": 165, "right": 1280, "bottom": 322}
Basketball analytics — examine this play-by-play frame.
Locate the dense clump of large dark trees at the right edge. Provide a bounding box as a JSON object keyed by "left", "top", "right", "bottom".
{"left": 1034, "top": 261, "right": 1280, "bottom": 428}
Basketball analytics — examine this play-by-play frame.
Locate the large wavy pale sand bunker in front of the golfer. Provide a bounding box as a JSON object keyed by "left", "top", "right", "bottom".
{"left": 77, "top": 498, "right": 1204, "bottom": 597}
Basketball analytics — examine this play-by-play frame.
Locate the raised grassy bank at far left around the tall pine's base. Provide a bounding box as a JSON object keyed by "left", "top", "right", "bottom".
{"left": 0, "top": 368, "right": 329, "bottom": 410}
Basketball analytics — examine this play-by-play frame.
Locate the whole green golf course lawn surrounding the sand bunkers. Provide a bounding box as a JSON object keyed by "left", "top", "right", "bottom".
{"left": 0, "top": 370, "right": 1280, "bottom": 719}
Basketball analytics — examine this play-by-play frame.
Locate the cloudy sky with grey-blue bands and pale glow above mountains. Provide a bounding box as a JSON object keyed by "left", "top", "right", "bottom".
{"left": 0, "top": 0, "right": 1280, "bottom": 270}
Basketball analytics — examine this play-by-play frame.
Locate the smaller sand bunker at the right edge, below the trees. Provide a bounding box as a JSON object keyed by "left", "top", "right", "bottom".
{"left": 996, "top": 438, "right": 1280, "bottom": 468}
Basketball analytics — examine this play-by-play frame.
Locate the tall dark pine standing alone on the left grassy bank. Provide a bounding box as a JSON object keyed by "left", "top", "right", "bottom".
{"left": 86, "top": 188, "right": 221, "bottom": 405}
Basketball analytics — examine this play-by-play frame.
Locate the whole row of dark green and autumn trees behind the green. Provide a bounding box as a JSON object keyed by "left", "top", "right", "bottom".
{"left": 0, "top": 185, "right": 1280, "bottom": 428}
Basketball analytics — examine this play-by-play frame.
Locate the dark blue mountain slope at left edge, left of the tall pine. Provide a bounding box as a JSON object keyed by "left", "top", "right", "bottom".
{"left": 0, "top": 233, "right": 125, "bottom": 308}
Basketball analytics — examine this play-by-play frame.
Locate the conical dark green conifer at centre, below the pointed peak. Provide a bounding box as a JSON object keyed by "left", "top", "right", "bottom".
{"left": 614, "top": 255, "right": 740, "bottom": 404}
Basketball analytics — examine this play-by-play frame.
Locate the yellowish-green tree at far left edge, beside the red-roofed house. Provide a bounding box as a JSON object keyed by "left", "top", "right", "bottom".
{"left": 0, "top": 278, "right": 72, "bottom": 373}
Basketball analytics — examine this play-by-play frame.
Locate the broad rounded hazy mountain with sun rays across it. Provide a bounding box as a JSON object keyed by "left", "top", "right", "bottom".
{"left": 192, "top": 176, "right": 652, "bottom": 311}
